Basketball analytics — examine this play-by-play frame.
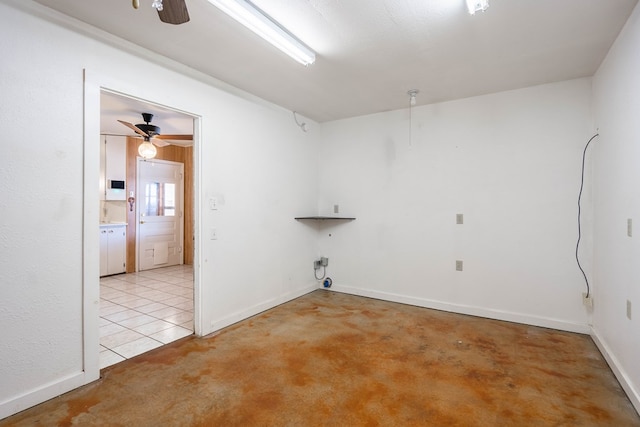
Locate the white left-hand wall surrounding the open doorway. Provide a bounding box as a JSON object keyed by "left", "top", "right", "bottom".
{"left": 0, "top": 0, "right": 318, "bottom": 418}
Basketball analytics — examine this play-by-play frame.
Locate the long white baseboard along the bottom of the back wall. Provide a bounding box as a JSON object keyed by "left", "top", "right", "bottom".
{"left": 331, "top": 283, "right": 591, "bottom": 335}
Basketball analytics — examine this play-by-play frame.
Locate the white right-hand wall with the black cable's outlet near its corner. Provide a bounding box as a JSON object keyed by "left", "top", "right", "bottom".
{"left": 593, "top": 1, "right": 640, "bottom": 410}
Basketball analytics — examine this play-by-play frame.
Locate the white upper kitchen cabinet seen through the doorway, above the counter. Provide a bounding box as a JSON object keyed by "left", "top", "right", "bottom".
{"left": 100, "top": 136, "right": 127, "bottom": 200}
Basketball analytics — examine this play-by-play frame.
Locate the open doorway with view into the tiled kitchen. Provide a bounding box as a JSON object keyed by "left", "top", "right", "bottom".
{"left": 99, "top": 90, "right": 195, "bottom": 369}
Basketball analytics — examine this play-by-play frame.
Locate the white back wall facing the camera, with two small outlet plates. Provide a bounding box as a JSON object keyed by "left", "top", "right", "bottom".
{"left": 318, "top": 79, "right": 593, "bottom": 332}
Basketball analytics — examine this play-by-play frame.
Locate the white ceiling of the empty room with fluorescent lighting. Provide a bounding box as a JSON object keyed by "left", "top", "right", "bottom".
{"left": 35, "top": 0, "right": 638, "bottom": 123}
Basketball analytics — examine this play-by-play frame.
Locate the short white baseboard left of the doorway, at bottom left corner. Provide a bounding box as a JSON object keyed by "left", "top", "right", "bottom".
{"left": 0, "top": 372, "right": 95, "bottom": 420}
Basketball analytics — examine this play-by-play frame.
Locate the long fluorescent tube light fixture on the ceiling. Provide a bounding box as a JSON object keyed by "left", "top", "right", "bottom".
{"left": 209, "top": 0, "right": 316, "bottom": 65}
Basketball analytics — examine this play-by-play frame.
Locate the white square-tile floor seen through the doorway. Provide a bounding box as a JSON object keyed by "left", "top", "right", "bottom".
{"left": 100, "top": 265, "right": 193, "bottom": 369}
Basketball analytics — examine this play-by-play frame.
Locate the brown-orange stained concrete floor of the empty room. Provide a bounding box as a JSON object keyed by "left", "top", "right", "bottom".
{"left": 0, "top": 290, "right": 640, "bottom": 426}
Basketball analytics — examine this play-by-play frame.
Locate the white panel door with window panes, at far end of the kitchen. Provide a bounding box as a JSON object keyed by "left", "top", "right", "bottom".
{"left": 137, "top": 159, "right": 184, "bottom": 271}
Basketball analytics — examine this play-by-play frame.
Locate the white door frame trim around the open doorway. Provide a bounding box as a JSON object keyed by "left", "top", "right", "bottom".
{"left": 83, "top": 69, "right": 202, "bottom": 382}
